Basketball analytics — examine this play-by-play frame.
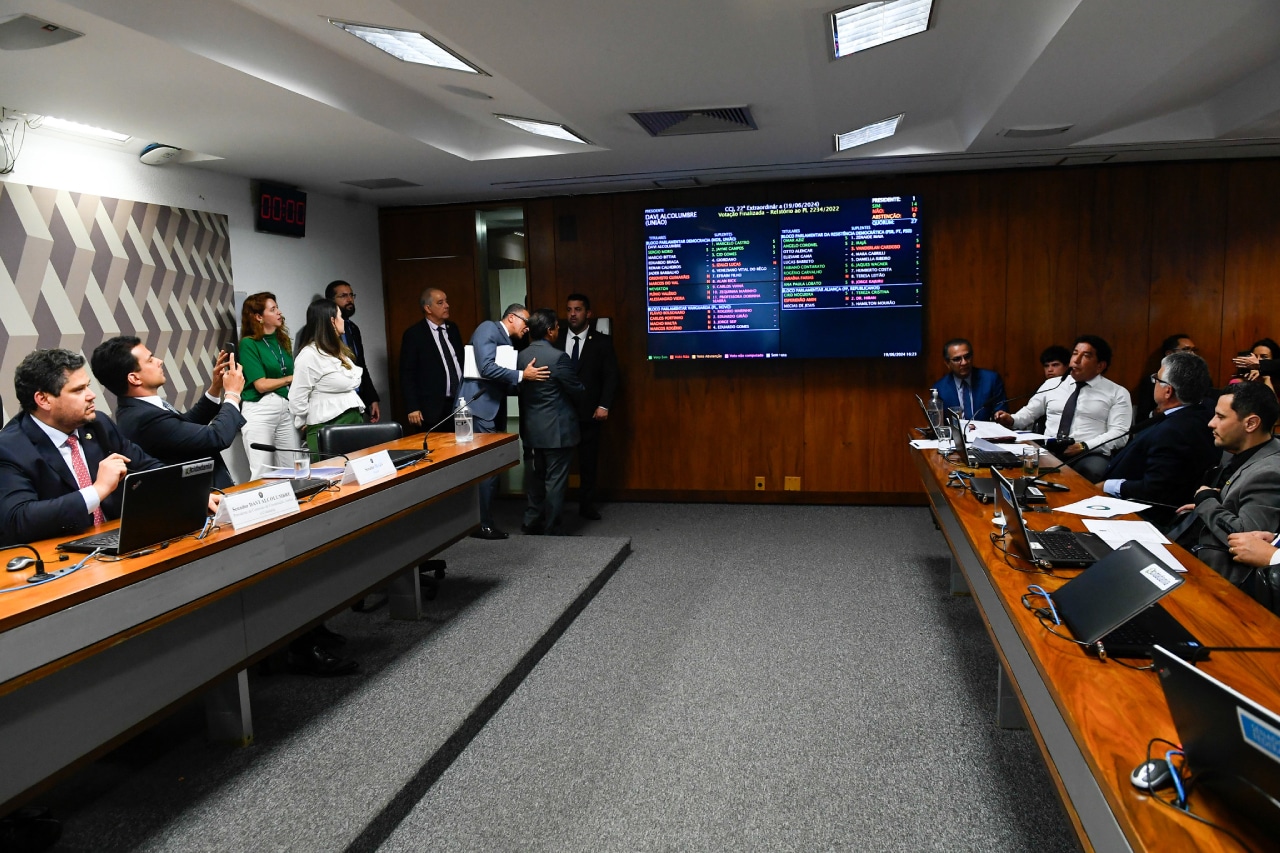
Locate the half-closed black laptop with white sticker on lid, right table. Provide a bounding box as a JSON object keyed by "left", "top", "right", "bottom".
{"left": 1051, "top": 542, "right": 1203, "bottom": 658}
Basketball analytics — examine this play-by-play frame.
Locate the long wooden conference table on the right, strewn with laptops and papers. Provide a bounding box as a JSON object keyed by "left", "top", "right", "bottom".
{"left": 911, "top": 440, "right": 1280, "bottom": 852}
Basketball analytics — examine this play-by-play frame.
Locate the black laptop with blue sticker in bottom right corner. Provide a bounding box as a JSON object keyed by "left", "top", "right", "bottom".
{"left": 1155, "top": 646, "right": 1280, "bottom": 840}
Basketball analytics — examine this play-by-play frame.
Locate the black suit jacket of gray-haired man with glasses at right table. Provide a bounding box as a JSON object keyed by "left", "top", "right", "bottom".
{"left": 1102, "top": 405, "right": 1222, "bottom": 519}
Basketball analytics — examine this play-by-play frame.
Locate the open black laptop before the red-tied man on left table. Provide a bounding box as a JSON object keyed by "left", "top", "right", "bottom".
{"left": 58, "top": 459, "right": 214, "bottom": 555}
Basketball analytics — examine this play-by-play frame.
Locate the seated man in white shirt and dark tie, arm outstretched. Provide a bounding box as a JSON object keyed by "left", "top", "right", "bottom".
{"left": 995, "top": 334, "right": 1133, "bottom": 482}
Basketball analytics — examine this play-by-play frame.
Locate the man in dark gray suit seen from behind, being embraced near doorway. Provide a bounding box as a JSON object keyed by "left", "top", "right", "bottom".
{"left": 516, "top": 309, "right": 586, "bottom": 535}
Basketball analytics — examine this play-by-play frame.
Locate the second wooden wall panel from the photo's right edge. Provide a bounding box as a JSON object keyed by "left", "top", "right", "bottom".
{"left": 1139, "top": 163, "right": 1236, "bottom": 382}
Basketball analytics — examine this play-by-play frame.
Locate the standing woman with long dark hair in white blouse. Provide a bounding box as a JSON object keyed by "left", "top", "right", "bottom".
{"left": 289, "top": 300, "right": 365, "bottom": 453}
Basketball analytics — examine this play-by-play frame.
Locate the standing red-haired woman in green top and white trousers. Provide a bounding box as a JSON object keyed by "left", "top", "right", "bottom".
{"left": 239, "top": 292, "right": 298, "bottom": 480}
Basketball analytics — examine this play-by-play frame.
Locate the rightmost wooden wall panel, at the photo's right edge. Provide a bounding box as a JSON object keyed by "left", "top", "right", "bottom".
{"left": 1219, "top": 160, "right": 1280, "bottom": 375}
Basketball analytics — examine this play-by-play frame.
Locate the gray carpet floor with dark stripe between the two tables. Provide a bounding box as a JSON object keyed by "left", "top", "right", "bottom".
{"left": 46, "top": 502, "right": 1076, "bottom": 853}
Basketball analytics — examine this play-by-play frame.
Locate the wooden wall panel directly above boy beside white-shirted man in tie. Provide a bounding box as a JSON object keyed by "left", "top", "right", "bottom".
{"left": 1003, "top": 170, "right": 1082, "bottom": 399}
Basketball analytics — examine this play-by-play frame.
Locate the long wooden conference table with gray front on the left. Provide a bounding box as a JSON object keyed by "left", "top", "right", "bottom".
{"left": 0, "top": 434, "right": 520, "bottom": 813}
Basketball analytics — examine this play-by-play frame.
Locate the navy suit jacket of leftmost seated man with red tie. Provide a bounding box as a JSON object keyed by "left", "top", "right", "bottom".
{"left": 0, "top": 412, "right": 161, "bottom": 544}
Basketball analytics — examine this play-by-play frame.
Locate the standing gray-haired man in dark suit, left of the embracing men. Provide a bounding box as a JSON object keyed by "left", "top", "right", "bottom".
{"left": 401, "top": 287, "right": 466, "bottom": 432}
